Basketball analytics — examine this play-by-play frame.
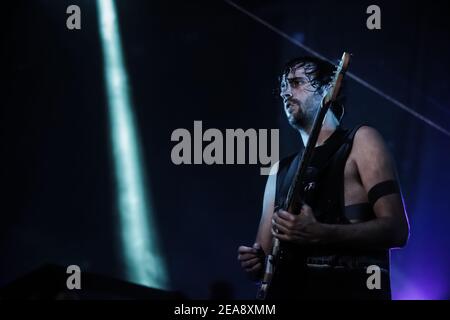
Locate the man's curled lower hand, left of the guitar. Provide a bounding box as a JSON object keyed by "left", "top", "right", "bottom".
{"left": 238, "top": 243, "right": 266, "bottom": 281}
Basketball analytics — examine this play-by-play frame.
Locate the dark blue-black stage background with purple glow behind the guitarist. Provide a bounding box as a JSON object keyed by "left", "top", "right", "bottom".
{"left": 0, "top": 0, "right": 450, "bottom": 299}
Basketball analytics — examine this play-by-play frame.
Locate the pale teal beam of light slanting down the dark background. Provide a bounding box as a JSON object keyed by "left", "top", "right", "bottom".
{"left": 97, "top": 0, "right": 168, "bottom": 289}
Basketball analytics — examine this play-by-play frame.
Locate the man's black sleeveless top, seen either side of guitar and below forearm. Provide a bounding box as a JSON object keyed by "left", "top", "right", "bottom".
{"left": 275, "top": 125, "right": 389, "bottom": 272}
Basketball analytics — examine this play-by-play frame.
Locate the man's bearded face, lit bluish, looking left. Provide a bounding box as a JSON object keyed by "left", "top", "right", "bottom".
{"left": 280, "top": 67, "right": 322, "bottom": 129}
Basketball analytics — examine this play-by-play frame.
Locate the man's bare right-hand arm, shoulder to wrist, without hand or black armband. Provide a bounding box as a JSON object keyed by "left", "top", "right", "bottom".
{"left": 318, "top": 126, "right": 409, "bottom": 248}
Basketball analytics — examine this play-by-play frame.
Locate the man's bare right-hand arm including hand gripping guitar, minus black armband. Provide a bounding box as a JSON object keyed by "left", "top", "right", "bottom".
{"left": 272, "top": 127, "right": 409, "bottom": 248}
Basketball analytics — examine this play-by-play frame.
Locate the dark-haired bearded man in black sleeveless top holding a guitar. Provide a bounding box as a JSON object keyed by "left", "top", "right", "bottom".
{"left": 238, "top": 57, "right": 409, "bottom": 299}
